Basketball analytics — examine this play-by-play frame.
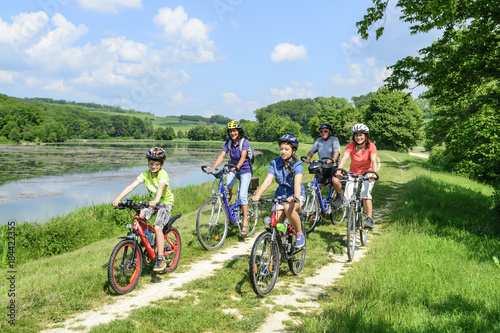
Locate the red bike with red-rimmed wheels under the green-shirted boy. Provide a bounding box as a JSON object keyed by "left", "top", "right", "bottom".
{"left": 108, "top": 200, "right": 181, "bottom": 295}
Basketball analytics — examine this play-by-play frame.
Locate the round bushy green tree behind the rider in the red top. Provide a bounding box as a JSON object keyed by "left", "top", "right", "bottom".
{"left": 365, "top": 88, "right": 422, "bottom": 151}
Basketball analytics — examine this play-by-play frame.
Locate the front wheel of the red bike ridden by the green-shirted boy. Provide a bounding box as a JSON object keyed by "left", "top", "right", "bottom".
{"left": 108, "top": 239, "right": 142, "bottom": 295}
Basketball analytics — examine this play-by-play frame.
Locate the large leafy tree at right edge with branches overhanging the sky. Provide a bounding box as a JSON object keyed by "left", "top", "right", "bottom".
{"left": 356, "top": 0, "right": 500, "bottom": 211}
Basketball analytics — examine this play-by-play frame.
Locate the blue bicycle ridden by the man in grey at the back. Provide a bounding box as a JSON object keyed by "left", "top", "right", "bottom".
{"left": 299, "top": 156, "right": 347, "bottom": 233}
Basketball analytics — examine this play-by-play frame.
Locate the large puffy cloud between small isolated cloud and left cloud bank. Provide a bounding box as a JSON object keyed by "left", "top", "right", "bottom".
{"left": 153, "top": 6, "right": 216, "bottom": 63}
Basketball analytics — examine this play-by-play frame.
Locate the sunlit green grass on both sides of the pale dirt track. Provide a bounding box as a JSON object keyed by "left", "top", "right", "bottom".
{"left": 0, "top": 144, "right": 500, "bottom": 332}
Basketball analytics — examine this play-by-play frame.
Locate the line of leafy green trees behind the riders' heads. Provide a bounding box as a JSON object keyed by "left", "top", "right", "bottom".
{"left": 187, "top": 88, "right": 432, "bottom": 151}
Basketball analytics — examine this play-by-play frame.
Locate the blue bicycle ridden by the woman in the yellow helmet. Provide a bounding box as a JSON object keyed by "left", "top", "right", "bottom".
{"left": 196, "top": 164, "right": 259, "bottom": 251}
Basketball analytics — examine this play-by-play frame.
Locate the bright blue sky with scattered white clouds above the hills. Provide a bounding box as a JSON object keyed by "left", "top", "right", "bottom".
{"left": 0, "top": 0, "right": 438, "bottom": 120}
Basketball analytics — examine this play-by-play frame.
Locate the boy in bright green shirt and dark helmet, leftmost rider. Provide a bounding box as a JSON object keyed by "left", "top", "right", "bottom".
{"left": 113, "top": 147, "right": 174, "bottom": 273}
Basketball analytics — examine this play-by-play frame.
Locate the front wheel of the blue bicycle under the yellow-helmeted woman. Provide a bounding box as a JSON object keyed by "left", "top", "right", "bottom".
{"left": 196, "top": 198, "right": 228, "bottom": 251}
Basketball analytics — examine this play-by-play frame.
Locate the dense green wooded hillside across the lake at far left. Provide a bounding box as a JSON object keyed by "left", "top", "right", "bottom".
{"left": 0, "top": 94, "right": 156, "bottom": 142}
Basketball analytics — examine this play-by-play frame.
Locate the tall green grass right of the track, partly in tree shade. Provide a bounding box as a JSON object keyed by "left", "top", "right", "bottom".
{"left": 294, "top": 158, "right": 500, "bottom": 332}
